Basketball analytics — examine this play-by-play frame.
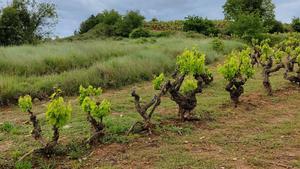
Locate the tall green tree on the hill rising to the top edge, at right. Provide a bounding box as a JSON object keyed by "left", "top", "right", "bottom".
{"left": 223, "top": 0, "right": 281, "bottom": 39}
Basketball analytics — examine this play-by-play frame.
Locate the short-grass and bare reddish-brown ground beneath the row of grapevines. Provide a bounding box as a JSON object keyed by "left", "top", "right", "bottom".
{"left": 0, "top": 58, "right": 300, "bottom": 169}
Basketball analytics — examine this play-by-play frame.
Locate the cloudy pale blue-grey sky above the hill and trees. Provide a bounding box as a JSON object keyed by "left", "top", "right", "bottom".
{"left": 0, "top": 0, "right": 300, "bottom": 37}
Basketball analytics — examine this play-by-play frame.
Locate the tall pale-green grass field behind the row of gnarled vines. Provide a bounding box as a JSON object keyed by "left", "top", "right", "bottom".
{"left": 0, "top": 36, "right": 243, "bottom": 105}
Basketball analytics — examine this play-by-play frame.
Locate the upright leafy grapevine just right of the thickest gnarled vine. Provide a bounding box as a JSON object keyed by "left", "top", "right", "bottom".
{"left": 219, "top": 49, "right": 254, "bottom": 107}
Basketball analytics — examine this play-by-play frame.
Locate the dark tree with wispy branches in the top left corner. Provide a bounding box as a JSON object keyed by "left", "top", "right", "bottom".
{"left": 0, "top": 0, "right": 57, "bottom": 45}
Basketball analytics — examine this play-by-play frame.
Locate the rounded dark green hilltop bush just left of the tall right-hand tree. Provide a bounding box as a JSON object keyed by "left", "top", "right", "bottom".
{"left": 183, "top": 16, "right": 218, "bottom": 36}
